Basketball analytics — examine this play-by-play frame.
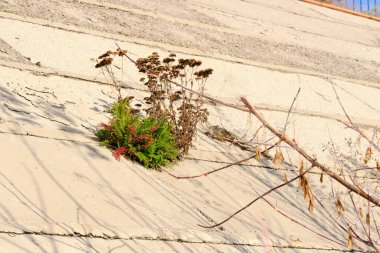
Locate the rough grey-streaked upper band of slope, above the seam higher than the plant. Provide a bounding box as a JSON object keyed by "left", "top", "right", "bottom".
{"left": 0, "top": 0, "right": 380, "bottom": 81}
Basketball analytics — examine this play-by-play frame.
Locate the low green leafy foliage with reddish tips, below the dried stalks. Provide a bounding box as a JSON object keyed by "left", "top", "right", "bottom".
{"left": 96, "top": 98, "right": 179, "bottom": 169}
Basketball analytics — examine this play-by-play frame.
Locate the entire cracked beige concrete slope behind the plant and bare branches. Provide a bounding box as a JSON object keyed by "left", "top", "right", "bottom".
{"left": 0, "top": 0, "right": 380, "bottom": 252}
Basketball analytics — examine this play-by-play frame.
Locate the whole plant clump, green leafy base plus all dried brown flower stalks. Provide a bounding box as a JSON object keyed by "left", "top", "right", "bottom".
{"left": 95, "top": 48, "right": 213, "bottom": 168}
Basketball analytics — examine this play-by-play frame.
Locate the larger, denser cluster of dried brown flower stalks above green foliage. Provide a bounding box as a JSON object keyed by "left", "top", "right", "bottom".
{"left": 136, "top": 53, "right": 213, "bottom": 155}
